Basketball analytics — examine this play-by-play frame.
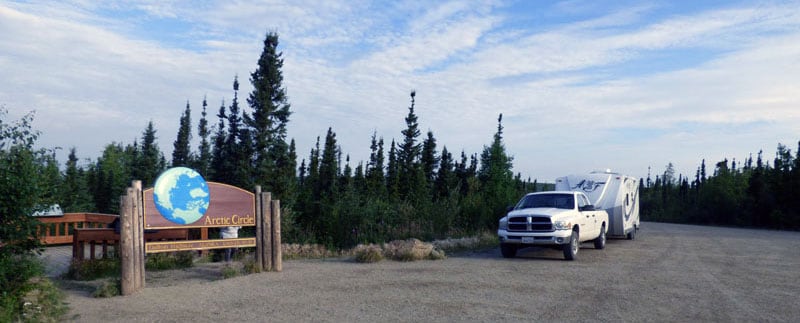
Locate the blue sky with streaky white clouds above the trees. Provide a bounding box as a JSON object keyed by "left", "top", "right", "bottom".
{"left": 0, "top": 0, "right": 800, "bottom": 182}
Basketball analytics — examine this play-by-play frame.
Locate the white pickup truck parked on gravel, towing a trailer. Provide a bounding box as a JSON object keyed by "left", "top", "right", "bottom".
{"left": 497, "top": 191, "right": 608, "bottom": 260}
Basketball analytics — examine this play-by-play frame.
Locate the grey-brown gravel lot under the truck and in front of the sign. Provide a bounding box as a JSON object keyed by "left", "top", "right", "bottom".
{"left": 62, "top": 223, "right": 800, "bottom": 322}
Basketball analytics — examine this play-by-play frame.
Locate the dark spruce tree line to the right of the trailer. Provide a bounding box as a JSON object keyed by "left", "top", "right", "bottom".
{"left": 640, "top": 142, "right": 800, "bottom": 230}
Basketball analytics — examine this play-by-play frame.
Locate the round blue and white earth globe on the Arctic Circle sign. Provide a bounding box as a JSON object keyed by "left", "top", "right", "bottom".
{"left": 153, "top": 167, "right": 210, "bottom": 224}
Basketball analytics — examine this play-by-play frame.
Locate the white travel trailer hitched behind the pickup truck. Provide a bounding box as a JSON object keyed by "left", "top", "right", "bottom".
{"left": 556, "top": 170, "right": 639, "bottom": 240}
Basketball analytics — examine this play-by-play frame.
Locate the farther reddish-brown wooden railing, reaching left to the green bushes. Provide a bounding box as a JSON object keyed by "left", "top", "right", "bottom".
{"left": 37, "top": 213, "right": 119, "bottom": 246}
